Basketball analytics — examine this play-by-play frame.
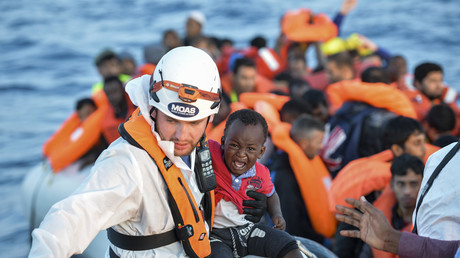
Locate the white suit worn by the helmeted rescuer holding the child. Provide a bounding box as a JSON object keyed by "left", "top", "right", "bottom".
{"left": 29, "top": 75, "right": 209, "bottom": 258}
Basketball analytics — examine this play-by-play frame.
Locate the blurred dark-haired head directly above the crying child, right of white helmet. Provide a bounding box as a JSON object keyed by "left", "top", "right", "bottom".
{"left": 233, "top": 57, "right": 257, "bottom": 95}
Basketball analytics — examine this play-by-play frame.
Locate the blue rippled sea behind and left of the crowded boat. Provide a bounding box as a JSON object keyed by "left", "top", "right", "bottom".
{"left": 0, "top": 0, "right": 460, "bottom": 257}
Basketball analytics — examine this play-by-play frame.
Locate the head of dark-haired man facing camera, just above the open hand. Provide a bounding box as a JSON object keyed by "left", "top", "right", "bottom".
{"left": 390, "top": 154, "right": 425, "bottom": 210}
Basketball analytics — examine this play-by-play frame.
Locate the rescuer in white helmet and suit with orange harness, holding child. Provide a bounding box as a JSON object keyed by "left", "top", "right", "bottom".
{"left": 29, "top": 47, "right": 266, "bottom": 257}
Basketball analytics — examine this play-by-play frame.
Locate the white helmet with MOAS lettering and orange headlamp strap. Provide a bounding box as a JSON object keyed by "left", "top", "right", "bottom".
{"left": 149, "top": 47, "right": 221, "bottom": 121}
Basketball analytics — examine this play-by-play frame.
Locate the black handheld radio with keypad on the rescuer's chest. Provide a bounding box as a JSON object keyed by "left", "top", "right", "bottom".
{"left": 195, "top": 135, "right": 217, "bottom": 193}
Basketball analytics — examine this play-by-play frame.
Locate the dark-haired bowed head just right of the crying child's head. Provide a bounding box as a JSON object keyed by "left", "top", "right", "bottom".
{"left": 290, "top": 115, "right": 324, "bottom": 159}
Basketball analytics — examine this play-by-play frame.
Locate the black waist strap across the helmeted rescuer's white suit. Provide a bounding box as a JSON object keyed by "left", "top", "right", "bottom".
{"left": 107, "top": 228, "right": 179, "bottom": 251}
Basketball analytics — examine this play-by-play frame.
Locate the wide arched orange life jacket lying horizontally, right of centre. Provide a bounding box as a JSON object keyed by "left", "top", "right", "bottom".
{"left": 326, "top": 80, "right": 417, "bottom": 119}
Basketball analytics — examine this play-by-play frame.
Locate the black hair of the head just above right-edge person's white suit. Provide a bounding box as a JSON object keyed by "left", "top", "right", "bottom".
{"left": 425, "top": 104, "right": 457, "bottom": 133}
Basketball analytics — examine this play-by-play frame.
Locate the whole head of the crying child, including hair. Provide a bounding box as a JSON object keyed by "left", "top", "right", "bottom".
{"left": 221, "top": 109, "right": 268, "bottom": 176}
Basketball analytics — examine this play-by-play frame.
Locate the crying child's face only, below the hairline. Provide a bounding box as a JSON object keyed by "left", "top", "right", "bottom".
{"left": 222, "top": 119, "right": 265, "bottom": 177}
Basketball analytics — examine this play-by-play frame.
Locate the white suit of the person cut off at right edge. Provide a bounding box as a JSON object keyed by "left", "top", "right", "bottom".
{"left": 412, "top": 142, "right": 460, "bottom": 240}
